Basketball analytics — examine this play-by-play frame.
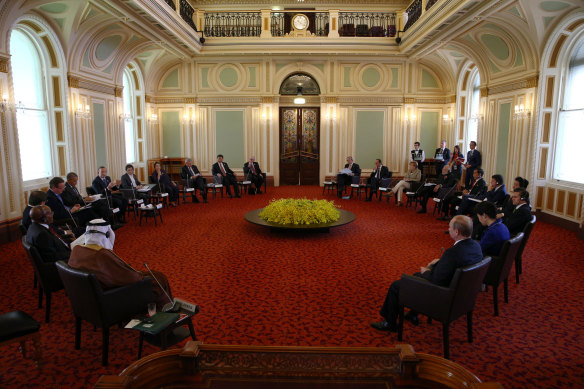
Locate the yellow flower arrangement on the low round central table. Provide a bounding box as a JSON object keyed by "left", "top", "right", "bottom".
{"left": 259, "top": 198, "right": 341, "bottom": 224}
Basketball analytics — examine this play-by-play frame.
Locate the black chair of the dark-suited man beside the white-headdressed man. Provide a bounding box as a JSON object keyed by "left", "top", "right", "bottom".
{"left": 22, "top": 236, "right": 63, "bottom": 323}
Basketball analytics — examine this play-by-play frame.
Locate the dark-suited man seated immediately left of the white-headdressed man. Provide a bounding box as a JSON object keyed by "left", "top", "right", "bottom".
{"left": 26, "top": 205, "right": 71, "bottom": 262}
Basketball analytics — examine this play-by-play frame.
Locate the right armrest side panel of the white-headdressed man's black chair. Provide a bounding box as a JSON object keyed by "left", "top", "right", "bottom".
{"left": 100, "top": 278, "right": 154, "bottom": 325}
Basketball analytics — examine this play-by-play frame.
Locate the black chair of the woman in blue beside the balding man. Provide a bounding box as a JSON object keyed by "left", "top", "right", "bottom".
{"left": 483, "top": 232, "right": 523, "bottom": 316}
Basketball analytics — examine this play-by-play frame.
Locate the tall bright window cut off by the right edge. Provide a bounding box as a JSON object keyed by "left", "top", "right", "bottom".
{"left": 553, "top": 41, "right": 584, "bottom": 184}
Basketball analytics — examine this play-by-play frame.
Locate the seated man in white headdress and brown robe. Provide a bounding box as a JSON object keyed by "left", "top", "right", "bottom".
{"left": 69, "top": 219, "right": 171, "bottom": 310}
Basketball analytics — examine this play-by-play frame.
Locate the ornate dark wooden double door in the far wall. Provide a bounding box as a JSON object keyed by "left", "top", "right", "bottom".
{"left": 280, "top": 107, "right": 320, "bottom": 185}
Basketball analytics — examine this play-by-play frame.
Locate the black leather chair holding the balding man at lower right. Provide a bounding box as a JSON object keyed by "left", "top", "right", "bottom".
{"left": 397, "top": 257, "right": 491, "bottom": 359}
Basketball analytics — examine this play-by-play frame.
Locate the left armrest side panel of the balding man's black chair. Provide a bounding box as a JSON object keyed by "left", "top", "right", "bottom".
{"left": 399, "top": 274, "right": 454, "bottom": 320}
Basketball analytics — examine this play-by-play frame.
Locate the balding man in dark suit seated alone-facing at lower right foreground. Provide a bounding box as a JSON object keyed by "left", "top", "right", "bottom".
{"left": 371, "top": 215, "right": 483, "bottom": 332}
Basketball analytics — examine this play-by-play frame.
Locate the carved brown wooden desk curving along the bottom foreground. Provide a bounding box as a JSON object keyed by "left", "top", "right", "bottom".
{"left": 94, "top": 341, "right": 502, "bottom": 389}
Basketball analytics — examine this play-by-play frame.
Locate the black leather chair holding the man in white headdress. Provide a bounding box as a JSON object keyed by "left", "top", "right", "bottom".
{"left": 57, "top": 261, "right": 154, "bottom": 366}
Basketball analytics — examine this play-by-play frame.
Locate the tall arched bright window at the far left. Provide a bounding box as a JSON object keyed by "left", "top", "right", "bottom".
{"left": 10, "top": 29, "right": 53, "bottom": 181}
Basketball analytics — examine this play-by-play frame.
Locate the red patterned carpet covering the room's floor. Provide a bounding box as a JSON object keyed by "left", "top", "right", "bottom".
{"left": 0, "top": 186, "right": 584, "bottom": 388}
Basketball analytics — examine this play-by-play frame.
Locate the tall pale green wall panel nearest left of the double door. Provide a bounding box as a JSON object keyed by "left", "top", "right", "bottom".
{"left": 215, "top": 111, "right": 245, "bottom": 164}
